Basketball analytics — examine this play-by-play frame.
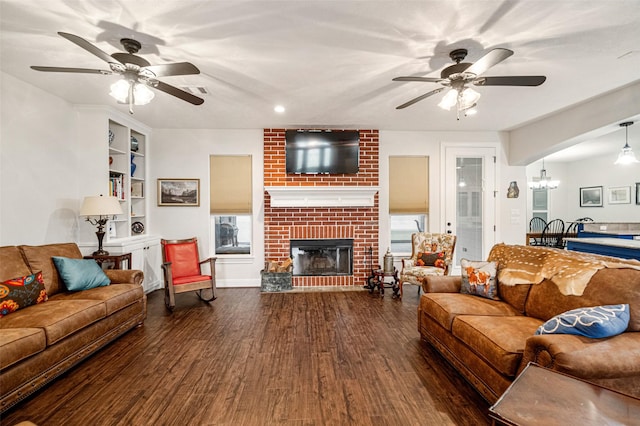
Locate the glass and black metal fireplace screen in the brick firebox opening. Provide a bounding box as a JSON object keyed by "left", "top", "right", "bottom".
{"left": 290, "top": 239, "right": 353, "bottom": 276}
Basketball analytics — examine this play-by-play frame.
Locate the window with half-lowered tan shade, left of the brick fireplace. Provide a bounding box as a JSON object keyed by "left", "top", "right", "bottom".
{"left": 209, "top": 155, "right": 253, "bottom": 255}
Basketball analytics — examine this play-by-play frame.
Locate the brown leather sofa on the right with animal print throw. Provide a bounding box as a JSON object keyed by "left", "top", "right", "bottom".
{"left": 418, "top": 244, "right": 640, "bottom": 403}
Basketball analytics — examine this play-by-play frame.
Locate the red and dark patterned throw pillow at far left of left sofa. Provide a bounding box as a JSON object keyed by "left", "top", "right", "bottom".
{"left": 0, "top": 272, "right": 47, "bottom": 317}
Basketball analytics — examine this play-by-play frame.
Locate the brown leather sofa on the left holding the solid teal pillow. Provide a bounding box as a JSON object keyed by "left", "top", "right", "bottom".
{"left": 0, "top": 243, "right": 146, "bottom": 413}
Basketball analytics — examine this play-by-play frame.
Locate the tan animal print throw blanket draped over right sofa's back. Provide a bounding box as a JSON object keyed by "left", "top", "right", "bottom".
{"left": 489, "top": 244, "right": 640, "bottom": 296}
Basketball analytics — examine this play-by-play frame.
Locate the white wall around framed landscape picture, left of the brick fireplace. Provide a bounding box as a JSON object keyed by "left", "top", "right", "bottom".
{"left": 147, "top": 129, "right": 264, "bottom": 287}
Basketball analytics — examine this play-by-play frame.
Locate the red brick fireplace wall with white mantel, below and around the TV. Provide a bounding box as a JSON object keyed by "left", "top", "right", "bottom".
{"left": 264, "top": 129, "right": 379, "bottom": 287}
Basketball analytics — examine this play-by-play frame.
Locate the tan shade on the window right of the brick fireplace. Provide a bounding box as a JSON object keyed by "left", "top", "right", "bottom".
{"left": 389, "top": 156, "right": 429, "bottom": 214}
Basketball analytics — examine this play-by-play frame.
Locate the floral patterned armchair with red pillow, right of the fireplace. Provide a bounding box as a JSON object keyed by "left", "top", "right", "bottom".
{"left": 400, "top": 232, "right": 456, "bottom": 297}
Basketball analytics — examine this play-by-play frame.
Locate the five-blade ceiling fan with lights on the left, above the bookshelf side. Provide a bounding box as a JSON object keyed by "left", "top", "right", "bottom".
{"left": 31, "top": 32, "right": 204, "bottom": 114}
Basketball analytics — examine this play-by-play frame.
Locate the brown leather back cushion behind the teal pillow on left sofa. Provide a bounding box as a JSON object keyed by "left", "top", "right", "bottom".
{"left": 20, "top": 243, "right": 82, "bottom": 296}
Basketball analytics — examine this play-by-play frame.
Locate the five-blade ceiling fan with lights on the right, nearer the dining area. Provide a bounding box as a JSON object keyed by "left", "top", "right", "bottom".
{"left": 393, "top": 48, "right": 547, "bottom": 119}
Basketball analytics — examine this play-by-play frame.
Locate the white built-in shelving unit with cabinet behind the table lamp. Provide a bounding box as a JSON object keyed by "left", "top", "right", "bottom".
{"left": 78, "top": 107, "right": 163, "bottom": 293}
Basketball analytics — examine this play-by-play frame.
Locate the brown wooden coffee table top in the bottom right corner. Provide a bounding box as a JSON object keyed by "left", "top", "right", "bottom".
{"left": 489, "top": 363, "right": 640, "bottom": 426}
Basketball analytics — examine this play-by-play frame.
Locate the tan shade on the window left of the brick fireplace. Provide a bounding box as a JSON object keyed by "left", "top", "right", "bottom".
{"left": 209, "top": 155, "right": 252, "bottom": 214}
